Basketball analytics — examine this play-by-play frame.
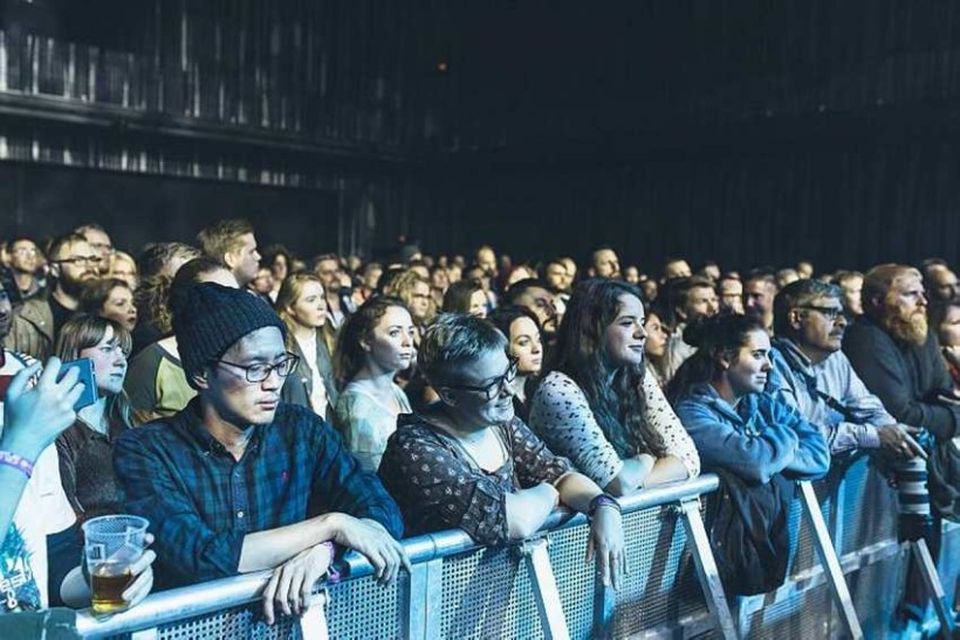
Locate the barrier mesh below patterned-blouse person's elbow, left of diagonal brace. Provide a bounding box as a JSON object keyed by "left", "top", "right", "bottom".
{"left": 440, "top": 544, "right": 544, "bottom": 639}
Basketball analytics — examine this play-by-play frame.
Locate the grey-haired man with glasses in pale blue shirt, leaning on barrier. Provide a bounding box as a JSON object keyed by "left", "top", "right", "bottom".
{"left": 767, "top": 279, "right": 920, "bottom": 458}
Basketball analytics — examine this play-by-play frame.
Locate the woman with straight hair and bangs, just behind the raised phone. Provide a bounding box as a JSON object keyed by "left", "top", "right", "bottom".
{"left": 56, "top": 314, "right": 133, "bottom": 518}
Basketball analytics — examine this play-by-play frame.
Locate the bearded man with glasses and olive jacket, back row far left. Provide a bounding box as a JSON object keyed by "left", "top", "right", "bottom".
{"left": 4, "top": 233, "right": 102, "bottom": 360}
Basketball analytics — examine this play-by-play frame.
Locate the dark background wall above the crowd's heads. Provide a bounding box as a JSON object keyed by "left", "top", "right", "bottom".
{"left": 0, "top": 0, "right": 960, "bottom": 270}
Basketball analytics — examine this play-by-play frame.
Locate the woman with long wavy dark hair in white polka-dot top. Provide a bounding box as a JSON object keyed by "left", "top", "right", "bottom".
{"left": 530, "top": 278, "right": 700, "bottom": 495}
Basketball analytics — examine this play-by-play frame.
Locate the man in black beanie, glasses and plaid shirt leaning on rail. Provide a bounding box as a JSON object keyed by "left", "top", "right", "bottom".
{"left": 114, "top": 283, "right": 409, "bottom": 623}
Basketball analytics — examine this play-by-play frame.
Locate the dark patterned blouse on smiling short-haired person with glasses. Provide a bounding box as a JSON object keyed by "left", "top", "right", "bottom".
{"left": 380, "top": 414, "right": 571, "bottom": 544}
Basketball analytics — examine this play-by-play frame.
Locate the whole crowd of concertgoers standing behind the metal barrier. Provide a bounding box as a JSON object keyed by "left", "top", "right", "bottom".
{"left": 0, "top": 220, "right": 960, "bottom": 622}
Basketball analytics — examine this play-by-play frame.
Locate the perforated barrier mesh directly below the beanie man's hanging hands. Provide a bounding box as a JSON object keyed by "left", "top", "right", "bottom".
{"left": 327, "top": 572, "right": 402, "bottom": 638}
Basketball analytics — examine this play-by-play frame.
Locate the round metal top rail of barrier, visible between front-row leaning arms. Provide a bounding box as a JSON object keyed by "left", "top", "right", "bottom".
{"left": 77, "top": 474, "right": 719, "bottom": 638}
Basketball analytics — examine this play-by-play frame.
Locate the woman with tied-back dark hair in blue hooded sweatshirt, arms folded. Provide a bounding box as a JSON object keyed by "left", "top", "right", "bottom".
{"left": 668, "top": 314, "right": 830, "bottom": 484}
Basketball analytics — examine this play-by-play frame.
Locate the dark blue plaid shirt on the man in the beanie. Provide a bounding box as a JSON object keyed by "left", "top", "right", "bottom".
{"left": 113, "top": 399, "right": 403, "bottom": 588}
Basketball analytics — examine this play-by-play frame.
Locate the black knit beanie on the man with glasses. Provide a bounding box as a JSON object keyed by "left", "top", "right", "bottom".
{"left": 171, "top": 282, "right": 287, "bottom": 389}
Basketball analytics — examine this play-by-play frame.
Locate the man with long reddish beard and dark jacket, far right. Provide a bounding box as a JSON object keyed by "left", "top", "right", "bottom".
{"left": 843, "top": 264, "right": 960, "bottom": 440}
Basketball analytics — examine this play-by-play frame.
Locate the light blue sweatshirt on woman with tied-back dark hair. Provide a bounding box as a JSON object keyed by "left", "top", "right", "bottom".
{"left": 677, "top": 383, "right": 830, "bottom": 483}
